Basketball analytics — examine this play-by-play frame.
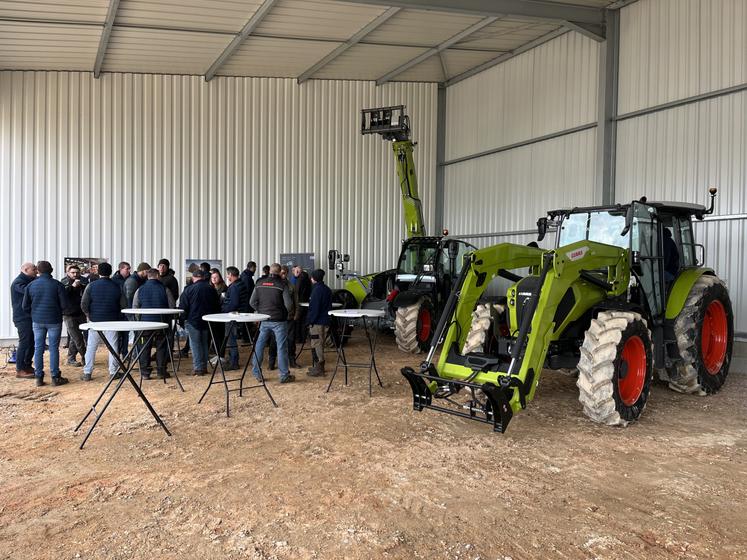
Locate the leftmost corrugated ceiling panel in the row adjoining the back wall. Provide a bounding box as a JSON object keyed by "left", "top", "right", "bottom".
{"left": 0, "top": 22, "right": 101, "bottom": 71}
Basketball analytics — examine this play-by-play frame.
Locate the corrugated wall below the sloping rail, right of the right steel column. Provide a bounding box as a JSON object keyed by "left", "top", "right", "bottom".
{"left": 616, "top": 92, "right": 747, "bottom": 333}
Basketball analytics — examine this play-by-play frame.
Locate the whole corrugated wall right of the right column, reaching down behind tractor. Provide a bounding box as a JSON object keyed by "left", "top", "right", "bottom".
{"left": 616, "top": 0, "right": 747, "bottom": 333}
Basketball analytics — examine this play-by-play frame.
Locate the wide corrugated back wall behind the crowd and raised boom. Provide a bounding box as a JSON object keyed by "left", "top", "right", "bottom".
{"left": 0, "top": 72, "right": 436, "bottom": 338}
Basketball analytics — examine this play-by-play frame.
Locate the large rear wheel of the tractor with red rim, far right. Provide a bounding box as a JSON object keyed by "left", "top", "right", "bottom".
{"left": 667, "top": 275, "right": 734, "bottom": 395}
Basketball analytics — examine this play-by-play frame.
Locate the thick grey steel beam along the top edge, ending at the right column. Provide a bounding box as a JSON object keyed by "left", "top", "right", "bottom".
{"left": 345, "top": 0, "right": 604, "bottom": 25}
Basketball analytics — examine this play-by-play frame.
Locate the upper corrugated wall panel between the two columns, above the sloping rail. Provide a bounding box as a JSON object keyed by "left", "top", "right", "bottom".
{"left": 446, "top": 33, "right": 599, "bottom": 160}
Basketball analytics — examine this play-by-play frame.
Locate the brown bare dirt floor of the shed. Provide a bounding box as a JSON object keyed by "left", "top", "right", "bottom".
{"left": 0, "top": 338, "right": 747, "bottom": 560}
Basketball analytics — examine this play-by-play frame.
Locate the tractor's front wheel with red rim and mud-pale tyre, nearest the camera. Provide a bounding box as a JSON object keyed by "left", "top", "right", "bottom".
{"left": 576, "top": 311, "right": 654, "bottom": 426}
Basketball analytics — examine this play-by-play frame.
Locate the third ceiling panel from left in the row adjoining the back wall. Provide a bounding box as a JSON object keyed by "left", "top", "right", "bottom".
{"left": 218, "top": 37, "right": 340, "bottom": 77}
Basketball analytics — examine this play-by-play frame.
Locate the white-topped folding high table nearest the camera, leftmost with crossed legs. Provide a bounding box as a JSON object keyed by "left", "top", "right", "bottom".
{"left": 74, "top": 321, "right": 171, "bottom": 449}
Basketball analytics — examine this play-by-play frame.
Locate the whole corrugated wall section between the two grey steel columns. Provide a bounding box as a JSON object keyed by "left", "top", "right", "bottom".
{"left": 444, "top": 33, "right": 599, "bottom": 238}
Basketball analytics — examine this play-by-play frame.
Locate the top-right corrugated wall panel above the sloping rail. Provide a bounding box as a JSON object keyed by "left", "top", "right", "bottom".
{"left": 618, "top": 0, "right": 747, "bottom": 114}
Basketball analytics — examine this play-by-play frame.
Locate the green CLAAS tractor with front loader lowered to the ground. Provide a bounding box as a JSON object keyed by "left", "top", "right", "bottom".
{"left": 402, "top": 188, "right": 734, "bottom": 432}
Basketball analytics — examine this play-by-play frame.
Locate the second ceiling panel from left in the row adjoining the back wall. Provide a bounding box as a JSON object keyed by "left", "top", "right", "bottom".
{"left": 104, "top": 27, "right": 231, "bottom": 74}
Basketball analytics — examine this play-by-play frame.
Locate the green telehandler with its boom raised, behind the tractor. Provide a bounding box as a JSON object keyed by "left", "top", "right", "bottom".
{"left": 328, "top": 105, "right": 475, "bottom": 353}
